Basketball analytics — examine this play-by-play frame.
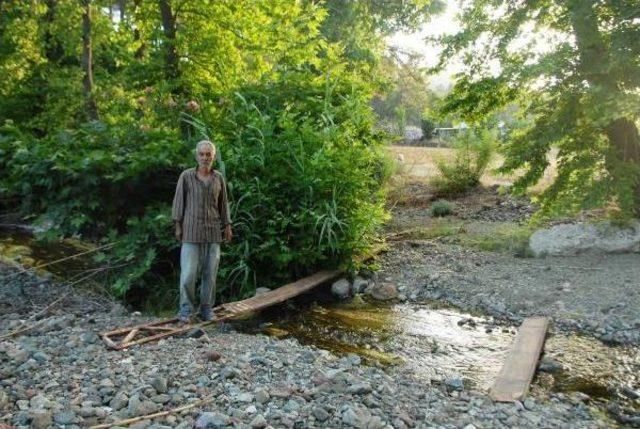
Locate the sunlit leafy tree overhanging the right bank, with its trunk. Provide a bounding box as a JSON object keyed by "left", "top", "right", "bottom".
{"left": 439, "top": 0, "right": 640, "bottom": 215}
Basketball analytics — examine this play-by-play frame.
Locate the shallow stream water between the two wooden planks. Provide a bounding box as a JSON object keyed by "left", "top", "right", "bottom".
{"left": 239, "top": 294, "right": 515, "bottom": 389}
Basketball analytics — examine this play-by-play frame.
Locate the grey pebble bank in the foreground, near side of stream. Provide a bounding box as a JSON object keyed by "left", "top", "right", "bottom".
{"left": 0, "top": 260, "right": 631, "bottom": 429}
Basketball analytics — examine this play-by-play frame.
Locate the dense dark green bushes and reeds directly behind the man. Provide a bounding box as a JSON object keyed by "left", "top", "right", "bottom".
{"left": 0, "top": 70, "right": 392, "bottom": 304}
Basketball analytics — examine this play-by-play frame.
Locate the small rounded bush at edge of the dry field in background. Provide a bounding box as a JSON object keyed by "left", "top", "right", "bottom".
{"left": 433, "top": 130, "right": 496, "bottom": 195}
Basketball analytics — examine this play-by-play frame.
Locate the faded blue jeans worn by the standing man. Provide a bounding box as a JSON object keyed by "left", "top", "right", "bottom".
{"left": 179, "top": 243, "right": 220, "bottom": 318}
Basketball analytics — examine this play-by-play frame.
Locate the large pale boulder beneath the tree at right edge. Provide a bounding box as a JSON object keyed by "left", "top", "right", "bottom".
{"left": 529, "top": 221, "right": 640, "bottom": 256}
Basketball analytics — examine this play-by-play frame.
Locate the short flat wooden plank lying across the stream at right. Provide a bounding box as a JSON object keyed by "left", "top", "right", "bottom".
{"left": 489, "top": 317, "right": 549, "bottom": 402}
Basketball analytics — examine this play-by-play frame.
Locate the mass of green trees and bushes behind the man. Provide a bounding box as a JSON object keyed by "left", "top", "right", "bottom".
{"left": 0, "top": 0, "right": 438, "bottom": 305}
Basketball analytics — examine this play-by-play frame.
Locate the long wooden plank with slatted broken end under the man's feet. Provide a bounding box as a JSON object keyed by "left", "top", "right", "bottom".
{"left": 100, "top": 270, "right": 342, "bottom": 350}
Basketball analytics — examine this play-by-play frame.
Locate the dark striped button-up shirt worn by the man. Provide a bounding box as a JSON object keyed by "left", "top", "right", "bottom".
{"left": 171, "top": 168, "right": 231, "bottom": 243}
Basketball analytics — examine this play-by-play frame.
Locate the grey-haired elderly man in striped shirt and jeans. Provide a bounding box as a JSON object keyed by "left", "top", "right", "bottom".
{"left": 172, "top": 140, "right": 233, "bottom": 323}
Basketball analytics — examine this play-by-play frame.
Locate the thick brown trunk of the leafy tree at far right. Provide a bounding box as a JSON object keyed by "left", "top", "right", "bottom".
{"left": 567, "top": 0, "right": 640, "bottom": 215}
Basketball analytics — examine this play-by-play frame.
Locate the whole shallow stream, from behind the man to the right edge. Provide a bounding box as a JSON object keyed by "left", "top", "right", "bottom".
{"left": 0, "top": 230, "right": 640, "bottom": 422}
